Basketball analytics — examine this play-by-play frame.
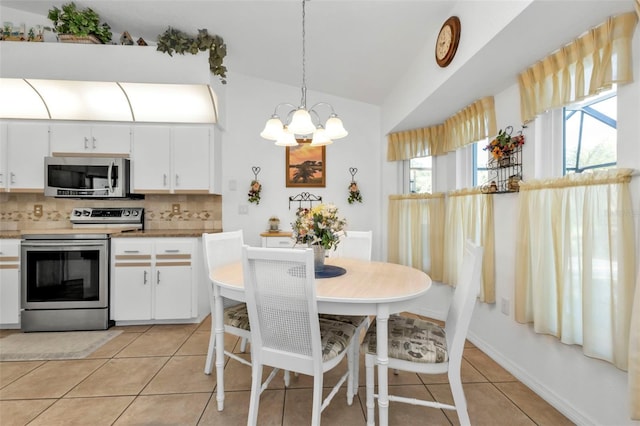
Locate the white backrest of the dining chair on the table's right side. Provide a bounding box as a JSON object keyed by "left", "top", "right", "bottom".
{"left": 444, "top": 240, "right": 483, "bottom": 363}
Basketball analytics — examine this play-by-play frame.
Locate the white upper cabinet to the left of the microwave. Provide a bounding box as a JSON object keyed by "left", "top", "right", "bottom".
{"left": 0, "top": 122, "right": 49, "bottom": 193}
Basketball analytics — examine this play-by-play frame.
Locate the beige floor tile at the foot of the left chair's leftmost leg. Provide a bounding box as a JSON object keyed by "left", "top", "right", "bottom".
{"left": 142, "top": 356, "right": 216, "bottom": 395}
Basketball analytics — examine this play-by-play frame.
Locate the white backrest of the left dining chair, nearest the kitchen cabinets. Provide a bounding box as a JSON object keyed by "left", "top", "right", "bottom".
{"left": 202, "top": 230, "right": 244, "bottom": 313}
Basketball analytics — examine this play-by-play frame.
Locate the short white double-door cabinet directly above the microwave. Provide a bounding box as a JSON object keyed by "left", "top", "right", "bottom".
{"left": 51, "top": 123, "right": 131, "bottom": 156}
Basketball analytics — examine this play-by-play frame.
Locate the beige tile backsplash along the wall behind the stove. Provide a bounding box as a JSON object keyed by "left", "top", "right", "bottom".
{"left": 0, "top": 193, "right": 222, "bottom": 231}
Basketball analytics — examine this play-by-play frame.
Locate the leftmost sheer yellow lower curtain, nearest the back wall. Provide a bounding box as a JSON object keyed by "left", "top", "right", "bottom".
{"left": 388, "top": 193, "right": 444, "bottom": 281}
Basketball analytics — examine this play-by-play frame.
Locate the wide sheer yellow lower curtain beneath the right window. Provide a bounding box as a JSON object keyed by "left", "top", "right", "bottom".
{"left": 515, "top": 169, "right": 637, "bottom": 372}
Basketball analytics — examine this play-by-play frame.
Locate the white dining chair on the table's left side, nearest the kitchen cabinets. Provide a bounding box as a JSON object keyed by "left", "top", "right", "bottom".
{"left": 202, "top": 230, "right": 251, "bottom": 374}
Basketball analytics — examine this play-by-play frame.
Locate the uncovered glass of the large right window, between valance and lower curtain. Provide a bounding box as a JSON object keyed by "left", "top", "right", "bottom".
{"left": 563, "top": 92, "right": 618, "bottom": 175}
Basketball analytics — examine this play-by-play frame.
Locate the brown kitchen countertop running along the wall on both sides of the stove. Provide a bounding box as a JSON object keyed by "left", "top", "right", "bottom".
{"left": 0, "top": 228, "right": 222, "bottom": 239}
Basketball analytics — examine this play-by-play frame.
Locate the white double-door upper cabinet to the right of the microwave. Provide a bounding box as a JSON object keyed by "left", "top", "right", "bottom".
{"left": 131, "top": 125, "right": 213, "bottom": 194}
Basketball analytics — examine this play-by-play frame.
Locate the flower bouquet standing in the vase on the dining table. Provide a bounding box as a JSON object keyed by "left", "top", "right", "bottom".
{"left": 291, "top": 204, "right": 347, "bottom": 250}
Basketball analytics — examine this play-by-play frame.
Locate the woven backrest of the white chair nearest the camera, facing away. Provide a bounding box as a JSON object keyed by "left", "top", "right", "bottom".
{"left": 242, "top": 245, "right": 322, "bottom": 374}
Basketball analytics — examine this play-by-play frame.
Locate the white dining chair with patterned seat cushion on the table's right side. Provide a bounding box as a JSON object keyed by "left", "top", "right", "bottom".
{"left": 362, "top": 241, "right": 482, "bottom": 425}
